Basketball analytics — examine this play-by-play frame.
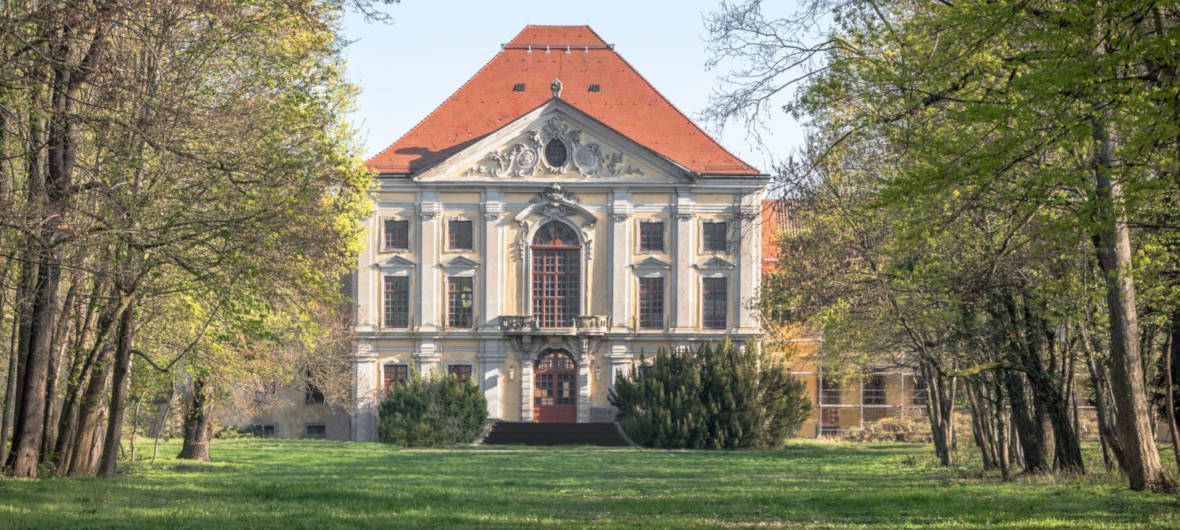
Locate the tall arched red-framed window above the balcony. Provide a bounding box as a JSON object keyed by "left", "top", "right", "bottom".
{"left": 532, "top": 221, "right": 582, "bottom": 328}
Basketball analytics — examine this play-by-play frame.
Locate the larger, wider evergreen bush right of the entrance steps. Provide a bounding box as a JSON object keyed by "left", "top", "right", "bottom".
{"left": 610, "top": 341, "right": 811, "bottom": 449}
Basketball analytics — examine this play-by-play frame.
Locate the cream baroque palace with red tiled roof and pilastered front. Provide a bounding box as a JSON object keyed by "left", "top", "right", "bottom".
{"left": 344, "top": 26, "right": 767, "bottom": 440}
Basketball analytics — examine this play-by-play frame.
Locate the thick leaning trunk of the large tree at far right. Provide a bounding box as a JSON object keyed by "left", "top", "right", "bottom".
{"left": 1093, "top": 118, "right": 1175, "bottom": 492}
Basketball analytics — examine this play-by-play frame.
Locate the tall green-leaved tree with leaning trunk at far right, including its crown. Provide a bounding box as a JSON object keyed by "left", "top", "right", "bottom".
{"left": 709, "top": 0, "right": 1180, "bottom": 491}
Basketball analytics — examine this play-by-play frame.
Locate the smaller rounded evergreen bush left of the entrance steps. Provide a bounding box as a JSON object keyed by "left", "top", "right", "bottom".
{"left": 378, "top": 373, "right": 487, "bottom": 447}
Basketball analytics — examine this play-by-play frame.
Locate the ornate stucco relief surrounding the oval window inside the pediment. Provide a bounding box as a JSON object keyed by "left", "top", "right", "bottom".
{"left": 464, "top": 116, "right": 643, "bottom": 178}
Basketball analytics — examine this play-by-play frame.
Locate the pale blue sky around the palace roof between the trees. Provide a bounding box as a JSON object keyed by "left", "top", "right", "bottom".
{"left": 345, "top": 0, "right": 802, "bottom": 172}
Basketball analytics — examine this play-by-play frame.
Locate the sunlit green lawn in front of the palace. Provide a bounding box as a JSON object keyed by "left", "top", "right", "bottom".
{"left": 0, "top": 440, "right": 1180, "bottom": 529}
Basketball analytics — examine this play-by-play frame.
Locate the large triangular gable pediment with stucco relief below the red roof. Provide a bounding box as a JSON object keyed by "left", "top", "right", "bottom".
{"left": 415, "top": 99, "right": 690, "bottom": 183}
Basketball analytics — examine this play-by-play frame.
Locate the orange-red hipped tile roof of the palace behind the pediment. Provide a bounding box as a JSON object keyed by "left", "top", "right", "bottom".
{"left": 367, "top": 26, "right": 760, "bottom": 176}
